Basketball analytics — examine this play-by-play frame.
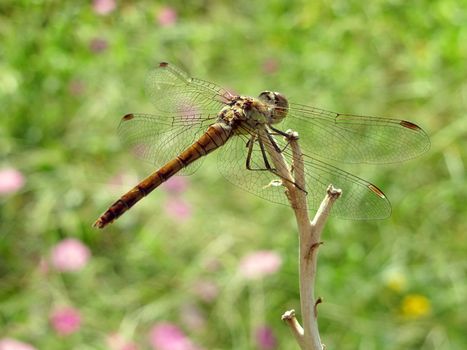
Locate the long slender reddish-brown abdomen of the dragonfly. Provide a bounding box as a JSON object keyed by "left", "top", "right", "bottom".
{"left": 94, "top": 122, "right": 232, "bottom": 228}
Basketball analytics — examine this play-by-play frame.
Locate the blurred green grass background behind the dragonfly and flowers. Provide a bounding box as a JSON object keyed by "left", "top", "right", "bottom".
{"left": 0, "top": 0, "right": 467, "bottom": 349}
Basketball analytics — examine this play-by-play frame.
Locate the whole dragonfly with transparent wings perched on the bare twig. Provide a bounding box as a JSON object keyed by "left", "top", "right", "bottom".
{"left": 94, "top": 62, "right": 430, "bottom": 228}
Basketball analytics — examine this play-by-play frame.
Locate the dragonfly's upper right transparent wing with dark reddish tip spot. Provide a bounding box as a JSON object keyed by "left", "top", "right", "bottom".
{"left": 278, "top": 103, "right": 430, "bottom": 164}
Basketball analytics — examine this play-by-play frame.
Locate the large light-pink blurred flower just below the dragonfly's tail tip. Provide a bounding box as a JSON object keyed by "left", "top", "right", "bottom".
{"left": 51, "top": 238, "right": 91, "bottom": 272}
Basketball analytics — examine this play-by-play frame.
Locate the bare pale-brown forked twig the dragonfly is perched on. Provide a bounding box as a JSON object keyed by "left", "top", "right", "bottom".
{"left": 262, "top": 130, "right": 342, "bottom": 350}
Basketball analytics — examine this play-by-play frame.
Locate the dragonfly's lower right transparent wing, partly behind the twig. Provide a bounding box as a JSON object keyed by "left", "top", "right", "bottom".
{"left": 218, "top": 129, "right": 391, "bottom": 220}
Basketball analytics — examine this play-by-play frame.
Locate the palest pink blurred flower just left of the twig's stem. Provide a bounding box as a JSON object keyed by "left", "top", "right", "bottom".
{"left": 239, "top": 250, "right": 282, "bottom": 279}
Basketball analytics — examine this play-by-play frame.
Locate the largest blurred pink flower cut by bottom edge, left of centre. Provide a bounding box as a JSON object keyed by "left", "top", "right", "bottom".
{"left": 149, "top": 322, "right": 199, "bottom": 350}
